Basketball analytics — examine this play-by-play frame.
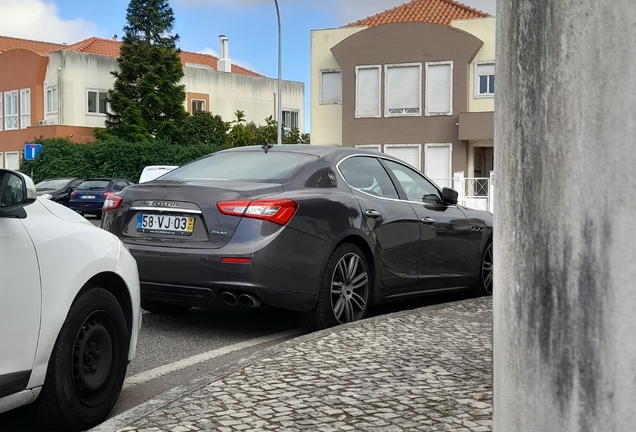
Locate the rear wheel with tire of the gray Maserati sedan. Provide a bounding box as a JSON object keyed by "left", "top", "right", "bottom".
{"left": 299, "top": 243, "right": 373, "bottom": 331}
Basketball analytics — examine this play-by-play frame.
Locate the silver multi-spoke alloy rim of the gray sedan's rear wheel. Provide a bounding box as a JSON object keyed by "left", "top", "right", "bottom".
{"left": 331, "top": 252, "right": 369, "bottom": 324}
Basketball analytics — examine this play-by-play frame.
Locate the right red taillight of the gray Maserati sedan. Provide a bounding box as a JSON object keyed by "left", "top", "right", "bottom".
{"left": 216, "top": 199, "right": 298, "bottom": 225}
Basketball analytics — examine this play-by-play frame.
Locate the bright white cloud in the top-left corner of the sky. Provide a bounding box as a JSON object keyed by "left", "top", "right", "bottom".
{"left": 0, "top": 0, "right": 97, "bottom": 43}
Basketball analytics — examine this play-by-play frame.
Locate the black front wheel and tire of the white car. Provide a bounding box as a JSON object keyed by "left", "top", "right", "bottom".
{"left": 34, "top": 286, "right": 130, "bottom": 431}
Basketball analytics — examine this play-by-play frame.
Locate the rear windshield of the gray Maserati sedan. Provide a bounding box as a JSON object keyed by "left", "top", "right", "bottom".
{"left": 161, "top": 151, "right": 317, "bottom": 182}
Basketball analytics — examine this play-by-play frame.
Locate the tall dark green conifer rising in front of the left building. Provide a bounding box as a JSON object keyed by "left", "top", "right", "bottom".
{"left": 106, "top": 0, "right": 186, "bottom": 141}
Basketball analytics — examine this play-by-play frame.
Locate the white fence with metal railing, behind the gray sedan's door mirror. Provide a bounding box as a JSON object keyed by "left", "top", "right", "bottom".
{"left": 431, "top": 171, "right": 495, "bottom": 213}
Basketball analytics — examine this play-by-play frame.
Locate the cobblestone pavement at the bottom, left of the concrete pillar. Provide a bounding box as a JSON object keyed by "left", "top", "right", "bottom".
{"left": 93, "top": 298, "right": 492, "bottom": 432}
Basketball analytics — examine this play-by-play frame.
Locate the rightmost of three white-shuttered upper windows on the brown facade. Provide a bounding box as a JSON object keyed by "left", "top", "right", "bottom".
{"left": 426, "top": 61, "right": 453, "bottom": 116}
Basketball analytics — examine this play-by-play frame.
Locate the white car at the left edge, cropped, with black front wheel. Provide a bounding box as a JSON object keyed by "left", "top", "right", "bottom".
{"left": 0, "top": 169, "right": 141, "bottom": 430}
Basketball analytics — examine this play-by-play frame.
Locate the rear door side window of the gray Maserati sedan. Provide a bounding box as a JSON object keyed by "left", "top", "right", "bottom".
{"left": 338, "top": 156, "right": 399, "bottom": 199}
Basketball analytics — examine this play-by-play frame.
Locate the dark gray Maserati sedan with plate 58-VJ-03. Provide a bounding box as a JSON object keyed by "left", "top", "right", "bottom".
{"left": 101, "top": 145, "right": 493, "bottom": 330}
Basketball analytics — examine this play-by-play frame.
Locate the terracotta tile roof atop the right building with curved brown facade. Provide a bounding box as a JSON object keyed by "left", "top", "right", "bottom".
{"left": 345, "top": 0, "right": 489, "bottom": 27}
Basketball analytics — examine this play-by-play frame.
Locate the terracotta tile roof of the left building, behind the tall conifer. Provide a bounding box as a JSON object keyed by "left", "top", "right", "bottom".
{"left": 0, "top": 36, "right": 262, "bottom": 76}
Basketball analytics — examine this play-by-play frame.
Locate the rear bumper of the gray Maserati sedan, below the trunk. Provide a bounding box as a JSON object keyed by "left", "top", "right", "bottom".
{"left": 127, "top": 228, "right": 333, "bottom": 311}
